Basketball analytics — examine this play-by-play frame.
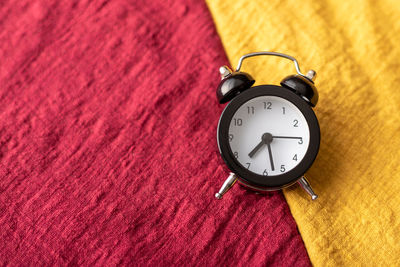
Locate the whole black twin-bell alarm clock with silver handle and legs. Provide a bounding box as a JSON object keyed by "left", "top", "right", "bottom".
{"left": 215, "top": 52, "right": 320, "bottom": 200}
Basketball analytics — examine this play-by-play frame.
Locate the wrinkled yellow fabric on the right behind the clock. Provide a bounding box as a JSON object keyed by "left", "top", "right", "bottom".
{"left": 207, "top": 0, "right": 400, "bottom": 266}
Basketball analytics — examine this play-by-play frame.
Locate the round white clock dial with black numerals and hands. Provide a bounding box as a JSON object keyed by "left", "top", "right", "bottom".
{"left": 229, "top": 96, "right": 310, "bottom": 176}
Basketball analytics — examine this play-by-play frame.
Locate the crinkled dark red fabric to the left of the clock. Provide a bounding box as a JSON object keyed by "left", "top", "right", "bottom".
{"left": 0, "top": 0, "right": 310, "bottom": 266}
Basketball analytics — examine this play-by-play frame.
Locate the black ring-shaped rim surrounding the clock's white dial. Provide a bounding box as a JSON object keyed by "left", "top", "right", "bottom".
{"left": 217, "top": 85, "right": 320, "bottom": 191}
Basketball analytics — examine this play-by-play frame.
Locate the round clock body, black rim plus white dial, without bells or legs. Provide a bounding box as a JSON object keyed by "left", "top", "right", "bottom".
{"left": 218, "top": 85, "right": 320, "bottom": 188}
